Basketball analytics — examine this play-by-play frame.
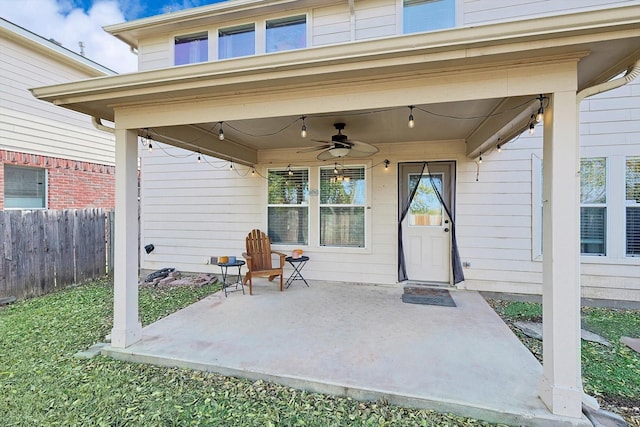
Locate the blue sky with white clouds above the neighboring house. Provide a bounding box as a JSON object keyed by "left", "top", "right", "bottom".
{"left": 0, "top": 0, "right": 223, "bottom": 73}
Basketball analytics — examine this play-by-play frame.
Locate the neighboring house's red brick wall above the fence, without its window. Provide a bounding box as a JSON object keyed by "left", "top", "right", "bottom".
{"left": 0, "top": 150, "right": 115, "bottom": 209}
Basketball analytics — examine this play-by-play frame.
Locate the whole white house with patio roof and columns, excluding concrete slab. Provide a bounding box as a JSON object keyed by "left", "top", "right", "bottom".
{"left": 33, "top": 0, "right": 640, "bottom": 418}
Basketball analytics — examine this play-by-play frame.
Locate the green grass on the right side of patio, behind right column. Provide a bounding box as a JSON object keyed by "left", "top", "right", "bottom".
{"left": 492, "top": 301, "right": 640, "bottom": 414}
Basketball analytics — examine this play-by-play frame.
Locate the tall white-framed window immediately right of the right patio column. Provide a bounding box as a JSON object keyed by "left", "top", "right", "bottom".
{"left": 580, "top": 157, "right": 607, "bottom": 256}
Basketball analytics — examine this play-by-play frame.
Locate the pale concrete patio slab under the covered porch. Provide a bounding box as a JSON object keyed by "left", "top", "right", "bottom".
{"left": 103, "top": 281, "right": 591, "bottom": 426}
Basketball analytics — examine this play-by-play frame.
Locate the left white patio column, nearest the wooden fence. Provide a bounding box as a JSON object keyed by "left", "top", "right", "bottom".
{"left": 111, "top": 129, "right": 142, "bottom": 348}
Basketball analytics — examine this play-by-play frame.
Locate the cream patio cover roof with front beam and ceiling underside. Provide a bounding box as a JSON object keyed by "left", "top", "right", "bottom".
{"left": 33, "top": 1, "right": 640, "bottom": 163}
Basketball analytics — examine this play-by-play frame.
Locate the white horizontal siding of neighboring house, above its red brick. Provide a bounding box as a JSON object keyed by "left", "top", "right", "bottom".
{"left": 0, "top": 32, "right": 115, "bottom": 165}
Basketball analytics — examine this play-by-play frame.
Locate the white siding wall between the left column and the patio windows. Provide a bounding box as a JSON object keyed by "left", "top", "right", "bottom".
{"left": 140, "top": 146, "right": 266, "bottom": 274}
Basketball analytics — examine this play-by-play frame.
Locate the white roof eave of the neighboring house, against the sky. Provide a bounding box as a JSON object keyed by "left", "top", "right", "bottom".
{"left": 0, "top": 18, "right": 116, "bottom": 77}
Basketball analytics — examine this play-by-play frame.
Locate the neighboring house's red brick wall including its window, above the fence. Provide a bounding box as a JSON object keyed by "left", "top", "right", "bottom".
{"left": 0, "top": 150, "right": 115, "bottom": 209}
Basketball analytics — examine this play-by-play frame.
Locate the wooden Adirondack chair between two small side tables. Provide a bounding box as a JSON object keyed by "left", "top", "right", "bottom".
{"left": 242, "top": 230, "right": 286, "bottom": 295}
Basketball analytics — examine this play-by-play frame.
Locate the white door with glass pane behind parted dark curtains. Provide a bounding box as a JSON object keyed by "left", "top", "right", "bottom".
{"left": 399, "top": 162, "right": 453, "bottom": 283}
